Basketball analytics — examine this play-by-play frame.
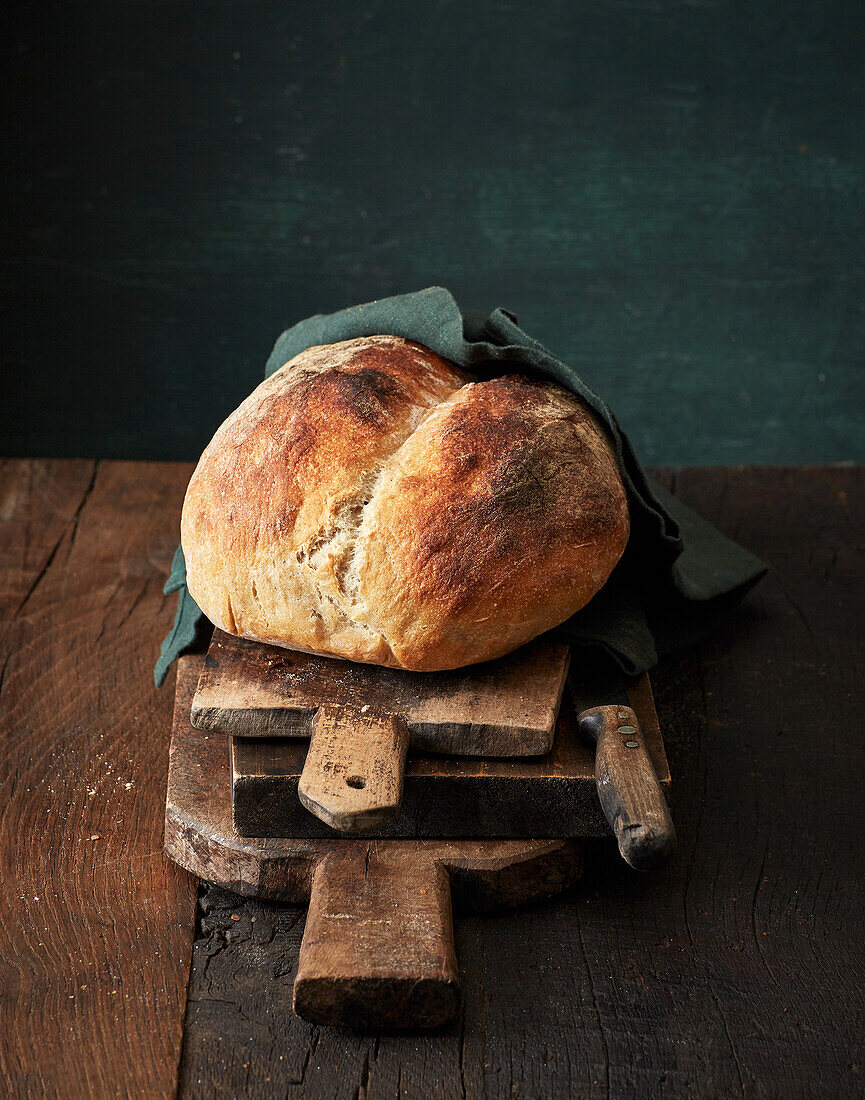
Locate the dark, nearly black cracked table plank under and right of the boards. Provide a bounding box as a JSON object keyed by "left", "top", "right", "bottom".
{"left": 182, "top": 469, "right": 865, "bottom": 1100}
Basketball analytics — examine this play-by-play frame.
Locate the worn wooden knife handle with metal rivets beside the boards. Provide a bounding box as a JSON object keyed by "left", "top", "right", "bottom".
{"left": 579, "top": 706, "right": 676, "bottom": 871}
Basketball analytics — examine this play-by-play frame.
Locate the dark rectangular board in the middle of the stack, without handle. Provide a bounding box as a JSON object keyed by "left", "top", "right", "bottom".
{"left": 231, "top": 677, "right": 670, "bottom": 837}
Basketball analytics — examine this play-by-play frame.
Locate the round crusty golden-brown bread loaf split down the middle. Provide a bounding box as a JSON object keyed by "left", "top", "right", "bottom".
{"left": 182, "top": 336, "right": 628, "bottom": 671}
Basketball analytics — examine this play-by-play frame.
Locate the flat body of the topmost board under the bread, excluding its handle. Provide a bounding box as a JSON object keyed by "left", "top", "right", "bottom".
{"left": 191, "top": 630, "right": 570, "bottom": 756}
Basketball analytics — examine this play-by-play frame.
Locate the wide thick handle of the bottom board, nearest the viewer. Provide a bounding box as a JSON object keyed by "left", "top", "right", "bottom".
{"left": 294, "top": 842, "right": 461, "bottom": 1030}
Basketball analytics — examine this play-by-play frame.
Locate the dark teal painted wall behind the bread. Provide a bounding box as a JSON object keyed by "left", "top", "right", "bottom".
{"left": 0, "top": 0, "right": 865, "bottom": 463}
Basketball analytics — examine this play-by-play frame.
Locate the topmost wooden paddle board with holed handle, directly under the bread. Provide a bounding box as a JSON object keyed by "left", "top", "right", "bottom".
{"left": 191, "top": 630, "right": 570, "bottom": 833}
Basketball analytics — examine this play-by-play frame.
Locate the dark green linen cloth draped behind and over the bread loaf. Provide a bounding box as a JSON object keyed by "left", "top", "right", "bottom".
{"left": 154, "top": 286, "right": 766, "bottom": 684}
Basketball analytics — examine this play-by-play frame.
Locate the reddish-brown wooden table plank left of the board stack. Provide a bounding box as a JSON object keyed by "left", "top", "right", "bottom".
{"left": 0, "top": 461, "right": 195, "bottom": 1098}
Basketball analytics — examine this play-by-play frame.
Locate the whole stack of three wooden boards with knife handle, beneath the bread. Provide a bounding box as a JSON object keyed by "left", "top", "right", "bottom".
{"left": 165, "top": 630, "right": 675, "bottom": 1027}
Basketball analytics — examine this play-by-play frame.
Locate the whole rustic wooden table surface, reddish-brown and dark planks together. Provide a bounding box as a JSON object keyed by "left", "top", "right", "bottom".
{"left": 0, "top": 461, "right": 865, "bottom": 1100}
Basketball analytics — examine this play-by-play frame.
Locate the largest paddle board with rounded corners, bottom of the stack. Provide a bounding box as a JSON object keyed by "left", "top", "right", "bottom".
{"left": 165, "top": 657, "right": 580, "bottom": 1029}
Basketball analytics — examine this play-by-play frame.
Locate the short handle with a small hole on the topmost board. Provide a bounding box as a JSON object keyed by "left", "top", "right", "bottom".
{"left": 297, "top": 706, "right": 408, "bottom": 833}
